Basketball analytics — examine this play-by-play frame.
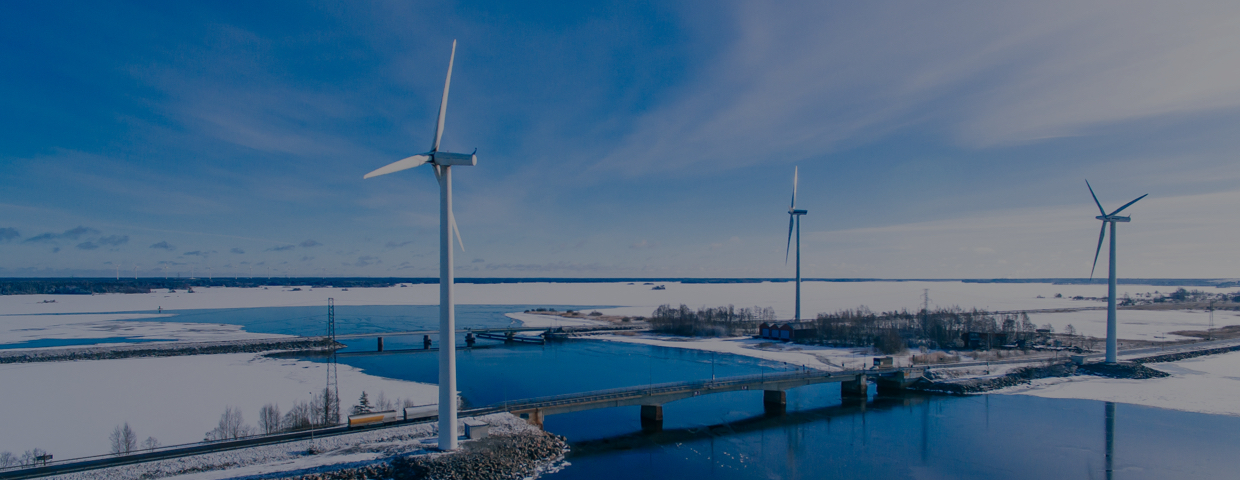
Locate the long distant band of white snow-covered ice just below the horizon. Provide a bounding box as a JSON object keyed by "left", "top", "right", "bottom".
{"left": 0, "top": 282, "right": 1190, "bottom": 318}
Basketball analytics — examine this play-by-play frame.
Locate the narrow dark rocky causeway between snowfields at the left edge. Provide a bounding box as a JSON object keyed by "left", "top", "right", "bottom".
{"left": 0, "top": 337, "right": 343, "bottom": 365}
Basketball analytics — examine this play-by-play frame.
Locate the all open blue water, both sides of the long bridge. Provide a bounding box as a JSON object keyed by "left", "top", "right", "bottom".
{"left": 140, "top": 305, "right": 1240, "bottom": 480}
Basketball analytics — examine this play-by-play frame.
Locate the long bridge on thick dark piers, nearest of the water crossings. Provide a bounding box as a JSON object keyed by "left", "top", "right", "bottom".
{"left": 490, "top": 367, "right": 924, "bottom": 430}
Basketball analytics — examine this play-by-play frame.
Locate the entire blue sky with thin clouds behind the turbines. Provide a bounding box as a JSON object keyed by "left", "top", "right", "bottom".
{"left": 0, "top": 1, "right": 1240, "bottom": 278}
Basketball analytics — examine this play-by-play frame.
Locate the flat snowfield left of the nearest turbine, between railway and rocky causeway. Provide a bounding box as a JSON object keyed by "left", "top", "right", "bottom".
{"left": 0, "top": 353, "right": 439, "bottom": 459}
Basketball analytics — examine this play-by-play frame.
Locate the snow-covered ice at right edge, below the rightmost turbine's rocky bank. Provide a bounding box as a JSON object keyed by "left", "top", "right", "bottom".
{"left": 992, "top": 352, "right": 1240, "bottom": 416}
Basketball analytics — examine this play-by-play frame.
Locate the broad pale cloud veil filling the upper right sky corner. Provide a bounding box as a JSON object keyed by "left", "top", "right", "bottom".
{"left": 592, "top": 1, "right": 1240, "bottom": 175}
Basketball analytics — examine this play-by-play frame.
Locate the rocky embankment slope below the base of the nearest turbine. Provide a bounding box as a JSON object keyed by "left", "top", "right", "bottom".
{"left": 283, "top": 430, "right": 568, "bottom": 480}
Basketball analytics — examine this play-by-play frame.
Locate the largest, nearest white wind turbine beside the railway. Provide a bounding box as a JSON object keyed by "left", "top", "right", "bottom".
{"left": 362, "top": 40, "right": 477, "bottom": 450}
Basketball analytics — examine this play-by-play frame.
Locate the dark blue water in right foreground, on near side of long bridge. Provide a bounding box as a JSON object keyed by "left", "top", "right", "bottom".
{"left": 547, "top": 394, "right": 1240, "bottom": 479}
